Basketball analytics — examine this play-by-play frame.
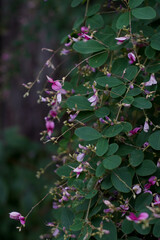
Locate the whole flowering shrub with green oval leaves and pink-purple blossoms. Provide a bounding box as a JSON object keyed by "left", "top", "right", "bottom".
{"left": 10, "top": 0, "right": 160, "bottom": 240}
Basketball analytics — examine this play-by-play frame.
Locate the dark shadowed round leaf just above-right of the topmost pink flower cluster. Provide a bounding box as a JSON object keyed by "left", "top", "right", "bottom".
{"left": 87, "top": 14, "right": 104, "bottom": 29}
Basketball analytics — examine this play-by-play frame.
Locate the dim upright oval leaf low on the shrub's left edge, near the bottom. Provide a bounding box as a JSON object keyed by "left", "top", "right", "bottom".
{"left": 61, "top": 208, "right": 74, "bottom": 229}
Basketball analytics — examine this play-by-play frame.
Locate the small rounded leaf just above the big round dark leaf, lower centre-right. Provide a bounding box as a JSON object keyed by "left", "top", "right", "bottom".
{"left": 103, "top": 155, "right": 122, "bottom": 170}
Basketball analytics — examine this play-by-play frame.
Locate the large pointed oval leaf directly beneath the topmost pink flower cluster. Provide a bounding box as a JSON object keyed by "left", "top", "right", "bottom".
{"left": 73, "top": 40, "right": 106, "bottom": 54}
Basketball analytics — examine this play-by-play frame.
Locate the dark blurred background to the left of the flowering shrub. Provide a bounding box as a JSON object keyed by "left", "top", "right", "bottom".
{"left": 0, "top": 0, "right": 81, "bottom": 240}
